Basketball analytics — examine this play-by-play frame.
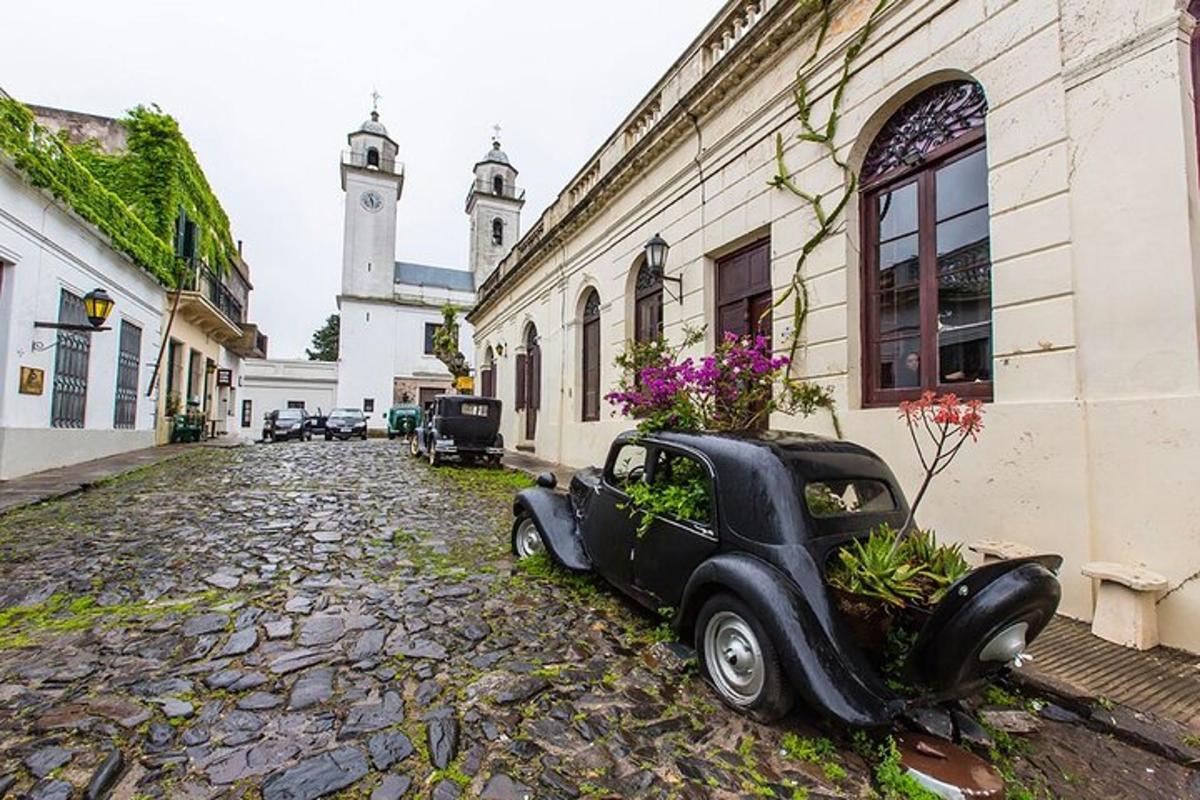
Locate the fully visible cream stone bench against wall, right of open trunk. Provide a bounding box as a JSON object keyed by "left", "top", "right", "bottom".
{"left": 1082, "top": 561, "right": 1168, "bottom": 650}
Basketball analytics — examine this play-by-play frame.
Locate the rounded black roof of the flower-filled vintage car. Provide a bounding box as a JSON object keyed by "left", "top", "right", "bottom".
{"left": 617, "top": 431, "right": 906, "bottom": 542}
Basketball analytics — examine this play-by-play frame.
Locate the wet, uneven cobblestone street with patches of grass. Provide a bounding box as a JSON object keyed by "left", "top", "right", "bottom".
{"left": 0, "top": 440, "right": 1195, "bottom": 800}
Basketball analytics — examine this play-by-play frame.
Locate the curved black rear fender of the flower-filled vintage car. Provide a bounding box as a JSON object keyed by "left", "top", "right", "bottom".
{"left": 674, "top": 553, "right": 905, "bottom": 727}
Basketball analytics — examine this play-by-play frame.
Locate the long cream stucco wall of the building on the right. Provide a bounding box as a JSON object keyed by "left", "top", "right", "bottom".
{"left": 473, "top": 0, "right": 1200, "bottom": 649}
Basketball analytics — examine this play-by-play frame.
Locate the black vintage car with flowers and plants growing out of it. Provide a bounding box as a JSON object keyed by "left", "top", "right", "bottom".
{"left": 512, "top": 433, "right": 1062, "bottom": 727}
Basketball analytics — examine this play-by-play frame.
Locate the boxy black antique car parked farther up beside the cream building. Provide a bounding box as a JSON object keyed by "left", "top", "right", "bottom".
{"left": 408, "top": 395, "right": 504, "bottom": 465}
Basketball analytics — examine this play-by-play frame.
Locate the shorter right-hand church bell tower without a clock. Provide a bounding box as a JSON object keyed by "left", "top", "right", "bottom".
{"left": 467, "top": 126, "right": 524, "bottom": 290}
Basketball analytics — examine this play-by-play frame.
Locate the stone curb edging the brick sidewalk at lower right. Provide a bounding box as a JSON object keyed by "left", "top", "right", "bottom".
{"left": 1012, "top": 670, "right": 1200, "bottom": 768}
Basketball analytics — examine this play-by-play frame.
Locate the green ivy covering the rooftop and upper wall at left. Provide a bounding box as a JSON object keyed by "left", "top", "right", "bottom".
{"left": 0, "top": 97, "right": 238, "bottom": 288}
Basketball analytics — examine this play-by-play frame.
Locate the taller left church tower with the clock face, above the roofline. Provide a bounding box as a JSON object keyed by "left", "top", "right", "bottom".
{"left": 338, "top": 110, "right": 404, "bottom": 301}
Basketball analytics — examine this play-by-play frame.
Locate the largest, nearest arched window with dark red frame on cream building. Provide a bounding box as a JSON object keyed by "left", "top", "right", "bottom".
{"left": 860, "top": 80, "right": 992, "bottom": 405}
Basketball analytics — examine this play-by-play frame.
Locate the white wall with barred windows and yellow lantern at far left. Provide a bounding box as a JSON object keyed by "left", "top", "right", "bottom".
{"left": 0, "top": 161, "right": 163, "bottom": 479}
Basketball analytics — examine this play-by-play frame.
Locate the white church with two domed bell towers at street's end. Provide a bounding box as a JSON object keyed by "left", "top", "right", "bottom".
{"left": 238, "top": 112, "right": 524, "bottom": 433}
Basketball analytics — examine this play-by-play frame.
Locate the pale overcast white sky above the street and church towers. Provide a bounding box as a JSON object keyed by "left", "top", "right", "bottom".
{"left": 0, "top": 0, "right": 724, "bottom": 357}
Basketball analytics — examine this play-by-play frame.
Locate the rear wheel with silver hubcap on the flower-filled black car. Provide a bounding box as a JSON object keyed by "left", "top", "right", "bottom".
{"left": 696, "top": 594, "right": 794, "bottom": 722}
